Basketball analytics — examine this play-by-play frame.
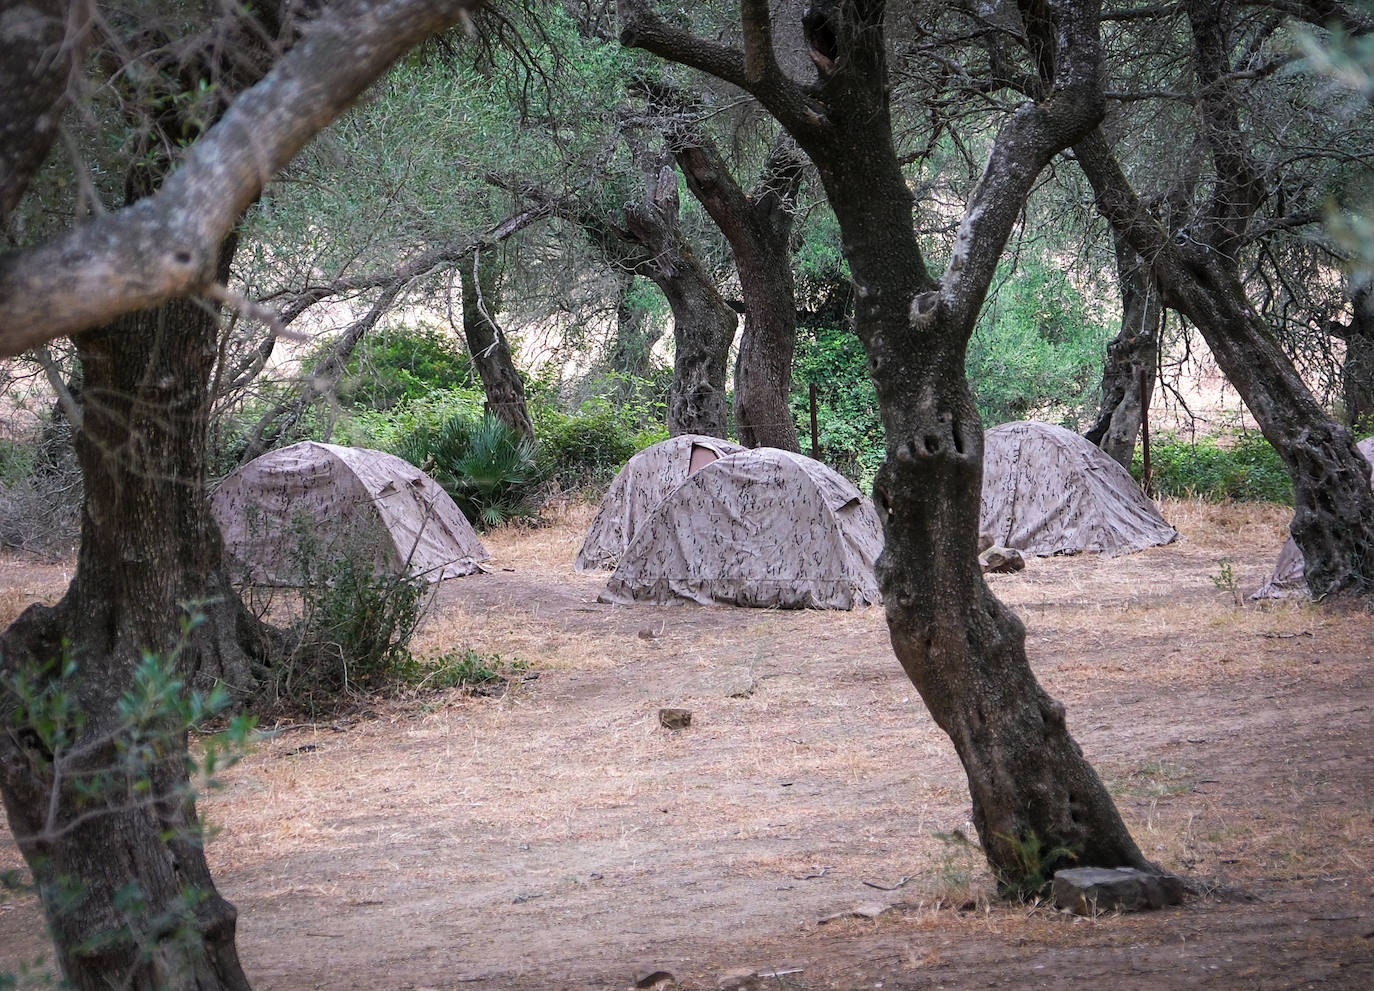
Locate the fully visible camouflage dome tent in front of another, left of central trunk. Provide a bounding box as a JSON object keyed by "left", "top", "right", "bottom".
{"left": 599, "top": 448, "right": 882, "bottom": 609}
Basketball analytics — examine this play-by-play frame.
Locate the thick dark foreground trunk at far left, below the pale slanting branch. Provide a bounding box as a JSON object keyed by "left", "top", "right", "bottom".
{"left": 0, "top": 281, "right": 273, "bottom": 991}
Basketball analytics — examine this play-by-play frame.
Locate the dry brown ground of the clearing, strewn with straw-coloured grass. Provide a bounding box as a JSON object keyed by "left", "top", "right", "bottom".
{"left": 0, "top": 503, "right": 1374, "bottom": 991}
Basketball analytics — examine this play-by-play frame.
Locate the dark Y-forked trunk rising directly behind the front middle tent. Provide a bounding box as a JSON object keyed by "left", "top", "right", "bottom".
{"left": 673, "top": 132, "right": 804, "bottom": 451}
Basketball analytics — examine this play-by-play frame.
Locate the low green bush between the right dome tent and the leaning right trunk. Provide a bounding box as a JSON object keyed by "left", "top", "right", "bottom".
{"left": 1131, "top": 433, "right": 1293, "bottom": 504}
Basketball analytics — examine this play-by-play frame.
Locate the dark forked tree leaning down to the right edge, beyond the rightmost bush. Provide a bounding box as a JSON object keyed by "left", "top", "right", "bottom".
{"left": 1074, "top": 0, "right": 1374, "bottom": 598}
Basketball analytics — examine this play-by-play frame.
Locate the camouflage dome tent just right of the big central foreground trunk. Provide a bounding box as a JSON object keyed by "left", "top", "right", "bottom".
{"left": 980, "top": 421, "right": 1178, "bottom": 557}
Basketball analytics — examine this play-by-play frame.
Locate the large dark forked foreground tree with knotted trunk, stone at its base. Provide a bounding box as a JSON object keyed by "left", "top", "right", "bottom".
{"left": 621, "top": 0, "right": 1149, "bottom": 888}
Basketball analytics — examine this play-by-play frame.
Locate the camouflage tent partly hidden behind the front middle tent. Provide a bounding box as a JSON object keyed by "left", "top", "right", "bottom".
{"left": 573, "top": 433, "right": 745, "bottom": 572}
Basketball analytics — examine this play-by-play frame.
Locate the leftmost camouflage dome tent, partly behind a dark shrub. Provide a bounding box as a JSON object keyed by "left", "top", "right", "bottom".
{"left": 210, "top": 441, "right": 489, "bottom": 586}
